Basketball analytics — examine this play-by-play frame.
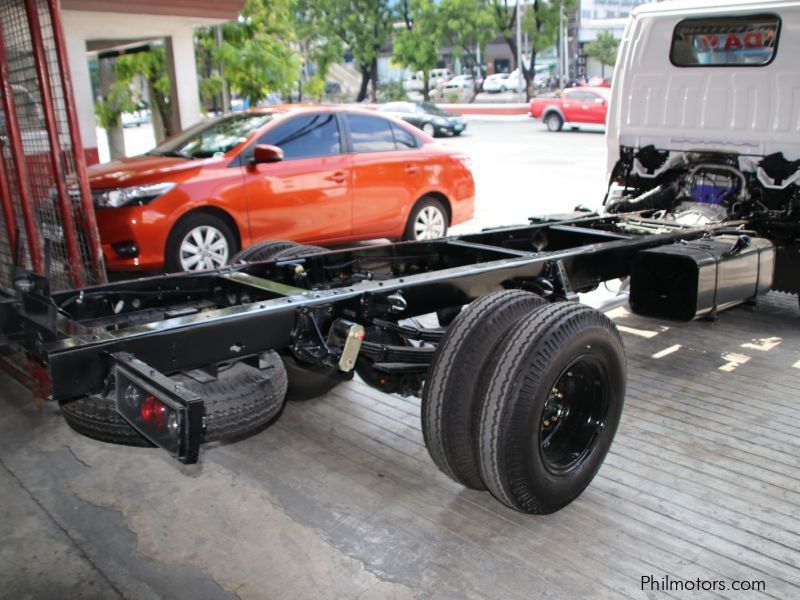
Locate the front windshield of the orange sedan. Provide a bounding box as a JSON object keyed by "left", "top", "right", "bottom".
{"left": 148, "top": 113, "right": 272, "bottom": 158}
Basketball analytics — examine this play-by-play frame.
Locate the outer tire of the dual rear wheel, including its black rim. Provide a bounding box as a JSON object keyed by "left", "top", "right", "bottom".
{"left": 479, "top": 302, "right": 625, "bottom": 514}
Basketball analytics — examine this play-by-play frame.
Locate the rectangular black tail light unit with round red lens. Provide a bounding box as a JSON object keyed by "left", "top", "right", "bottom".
{"left": 114, "top": 353, "right": 203, "bottom": 463}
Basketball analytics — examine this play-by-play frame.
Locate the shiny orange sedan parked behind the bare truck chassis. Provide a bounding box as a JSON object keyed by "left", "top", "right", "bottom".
{"left": 89, "top": 107, "right": 475, "bottom": 271}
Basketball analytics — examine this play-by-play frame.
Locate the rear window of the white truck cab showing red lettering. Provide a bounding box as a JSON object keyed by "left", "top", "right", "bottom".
{"left": 669, "top": 15, "right": 781, "bottom": 67}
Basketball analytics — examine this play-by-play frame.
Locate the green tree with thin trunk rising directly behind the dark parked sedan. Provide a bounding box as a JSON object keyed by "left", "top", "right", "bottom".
{"left": 394, "top": 0, "right": 442, "bottom": 100}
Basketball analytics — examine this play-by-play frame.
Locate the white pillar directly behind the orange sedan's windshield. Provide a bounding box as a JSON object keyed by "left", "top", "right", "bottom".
{"left": 167, "top": 27, "right": 203, "bottom": 129}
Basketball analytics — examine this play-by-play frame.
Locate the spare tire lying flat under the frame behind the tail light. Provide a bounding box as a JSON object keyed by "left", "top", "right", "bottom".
{"left": 60, "top": 352, "right": 287, "bottom": 446}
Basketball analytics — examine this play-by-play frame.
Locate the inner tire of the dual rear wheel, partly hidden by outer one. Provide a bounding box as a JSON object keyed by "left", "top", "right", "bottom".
{"left": 421, "top": 290, "right": 545, "bottom": 490}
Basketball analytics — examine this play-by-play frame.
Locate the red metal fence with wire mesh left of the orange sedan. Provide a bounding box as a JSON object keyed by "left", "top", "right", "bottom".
{"left": 0, "top": 0, "right": 105, "bottom": 291}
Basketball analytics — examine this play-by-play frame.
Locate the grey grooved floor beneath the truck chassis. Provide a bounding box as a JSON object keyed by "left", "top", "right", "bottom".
{"left": 0, "top": 294, "right": 800, "bottom": 599}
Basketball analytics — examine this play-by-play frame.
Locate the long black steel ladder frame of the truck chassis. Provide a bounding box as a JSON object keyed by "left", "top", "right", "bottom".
{"left": 0, "top": 215, "right": 712, "bottom": 400}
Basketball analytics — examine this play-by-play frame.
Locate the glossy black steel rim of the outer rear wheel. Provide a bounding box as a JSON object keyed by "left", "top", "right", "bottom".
{"left": 537, "top": 355, "right": 609, "bottom": 475}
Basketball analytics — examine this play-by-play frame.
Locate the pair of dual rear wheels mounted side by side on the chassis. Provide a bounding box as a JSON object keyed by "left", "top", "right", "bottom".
{"left": 422, "top": 290, "right": 625, "bottom": 514}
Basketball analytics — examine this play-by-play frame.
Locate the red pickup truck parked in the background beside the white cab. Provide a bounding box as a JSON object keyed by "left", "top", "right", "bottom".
{"left": 528, "top": 86, "right": 611, "bottom": 131}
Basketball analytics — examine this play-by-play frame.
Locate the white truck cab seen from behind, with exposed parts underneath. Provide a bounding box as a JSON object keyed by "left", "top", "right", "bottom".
{"left": 606, "top": 0, "right": 800, "bottom": 300}
